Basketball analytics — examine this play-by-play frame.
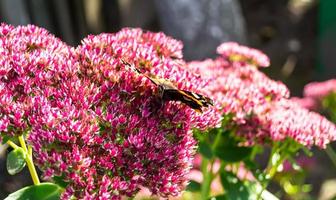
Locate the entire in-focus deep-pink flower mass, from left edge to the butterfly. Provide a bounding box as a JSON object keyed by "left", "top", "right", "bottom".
{"left": 0, "top": 24, "right": 220, "bottom": 199}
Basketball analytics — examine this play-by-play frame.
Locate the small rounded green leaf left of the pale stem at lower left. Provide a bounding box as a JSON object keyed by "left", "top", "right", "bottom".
{"left": 7, "top": 147, "right": 26, "bottom": 175}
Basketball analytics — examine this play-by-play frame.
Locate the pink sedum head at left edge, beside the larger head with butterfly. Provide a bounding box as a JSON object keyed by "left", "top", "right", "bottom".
{"left": 0, "top": 24, "right": 72, "bottom": 140}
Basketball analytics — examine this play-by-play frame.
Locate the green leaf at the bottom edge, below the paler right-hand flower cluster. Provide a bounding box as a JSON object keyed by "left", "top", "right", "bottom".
{"left": 220, "top": 168, "right": 251, "bottom": 200}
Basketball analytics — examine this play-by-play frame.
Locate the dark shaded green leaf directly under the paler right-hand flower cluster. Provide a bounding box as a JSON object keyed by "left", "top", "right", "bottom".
{"left": 214, "top": 145, "right": 252, "bottom": 162}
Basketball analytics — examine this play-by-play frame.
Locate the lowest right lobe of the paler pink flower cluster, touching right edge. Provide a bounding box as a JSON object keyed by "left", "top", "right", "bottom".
{"left": 265, "top": 99, "right": 336, "bottom": 148}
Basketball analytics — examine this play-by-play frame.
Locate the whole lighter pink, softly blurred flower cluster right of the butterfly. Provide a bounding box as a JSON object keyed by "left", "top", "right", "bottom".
{"left": 188, "top": 43, "right": 336, "bottom": 148}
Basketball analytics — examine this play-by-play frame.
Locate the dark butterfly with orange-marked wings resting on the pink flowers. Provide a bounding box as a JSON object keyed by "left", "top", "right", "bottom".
{"left": 122, "top": 60, "right": 214, "bottom": 113}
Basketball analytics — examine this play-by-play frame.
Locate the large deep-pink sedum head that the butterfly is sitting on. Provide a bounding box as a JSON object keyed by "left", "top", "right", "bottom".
{"left": 30, "top": 29, "right": 220, "bottom": 199}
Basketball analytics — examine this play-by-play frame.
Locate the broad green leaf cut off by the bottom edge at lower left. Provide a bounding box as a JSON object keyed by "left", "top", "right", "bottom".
{"left": 5, "top": 183, "right": 62, "bottom": 200}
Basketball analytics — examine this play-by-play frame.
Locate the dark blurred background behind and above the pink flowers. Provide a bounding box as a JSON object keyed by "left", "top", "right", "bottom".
{"left": 0, "top": 0, "right": 336, "bottom": 199}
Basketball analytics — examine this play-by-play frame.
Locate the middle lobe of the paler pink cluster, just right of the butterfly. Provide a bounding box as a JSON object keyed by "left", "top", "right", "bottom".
{"left": 188, "top": 58, "right": 289, "bottom": 123}
